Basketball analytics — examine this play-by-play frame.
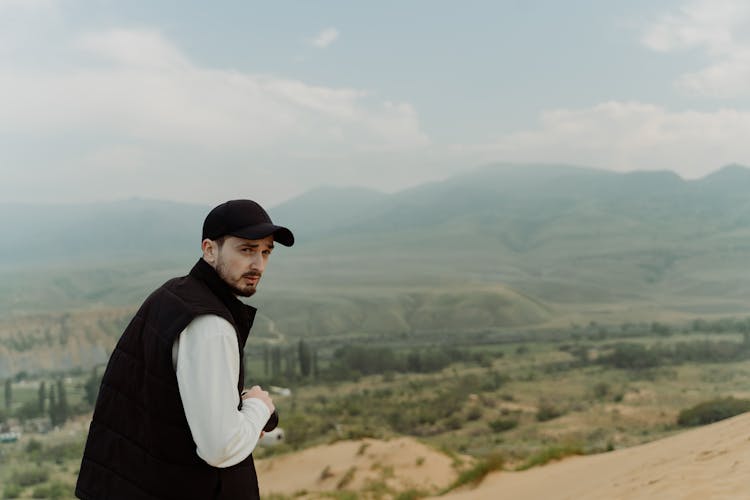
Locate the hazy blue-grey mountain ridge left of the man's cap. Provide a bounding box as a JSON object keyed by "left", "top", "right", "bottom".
{"left": 0, "top": 199, "right": 210, "bottom": 270}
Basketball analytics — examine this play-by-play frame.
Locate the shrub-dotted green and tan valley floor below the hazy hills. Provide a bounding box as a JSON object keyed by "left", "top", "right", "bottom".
{"left": 0, "top": 316, "right": 750, "bottom": 498}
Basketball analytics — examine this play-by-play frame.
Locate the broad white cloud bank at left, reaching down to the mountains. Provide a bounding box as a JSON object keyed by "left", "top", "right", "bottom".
{"left": 0, "top": 29, "right": 430, "bottom": 201}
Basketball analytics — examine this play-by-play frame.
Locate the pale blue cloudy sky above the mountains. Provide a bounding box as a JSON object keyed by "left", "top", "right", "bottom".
{"left": 0, "top": 0, "right": 750, "bottom": 205}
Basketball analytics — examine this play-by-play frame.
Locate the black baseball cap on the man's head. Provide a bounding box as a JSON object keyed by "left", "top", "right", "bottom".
{"left": 202, "top": 200, "right": 294, "bottom": 247}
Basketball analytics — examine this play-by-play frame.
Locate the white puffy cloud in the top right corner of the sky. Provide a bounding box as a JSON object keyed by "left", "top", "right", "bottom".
{"left": 642, "top": 0, "right": 750, "bottom": 98}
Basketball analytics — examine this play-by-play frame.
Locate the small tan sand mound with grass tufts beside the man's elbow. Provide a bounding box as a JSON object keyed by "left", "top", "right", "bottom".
{"left": 256, "top": 438, "right": 456, "bottom": 495}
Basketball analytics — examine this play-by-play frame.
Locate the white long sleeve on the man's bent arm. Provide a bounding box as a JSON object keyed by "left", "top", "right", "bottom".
{"left": 172, "top": 315, "right": 271, "bottom": 467}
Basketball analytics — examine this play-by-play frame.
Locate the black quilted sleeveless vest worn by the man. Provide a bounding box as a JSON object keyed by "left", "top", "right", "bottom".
{"left": 76, "top": 259, "right": 259, "bottom": 500}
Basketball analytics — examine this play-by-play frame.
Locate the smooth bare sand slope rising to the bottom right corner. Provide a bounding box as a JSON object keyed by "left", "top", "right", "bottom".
{"left": 440, "top": 414, "right": 750, "bottom": 500}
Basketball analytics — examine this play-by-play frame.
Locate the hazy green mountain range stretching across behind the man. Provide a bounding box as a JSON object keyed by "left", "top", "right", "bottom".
{"left": 0, "top": 165, "right": 750, "bottom": 373}
